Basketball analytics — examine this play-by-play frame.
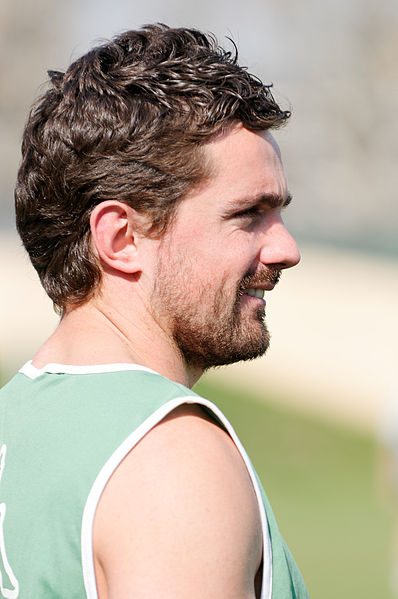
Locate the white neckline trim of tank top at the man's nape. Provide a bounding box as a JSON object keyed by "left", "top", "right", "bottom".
{"left": 19, "top": 360, "right": 161, "bottom": 379}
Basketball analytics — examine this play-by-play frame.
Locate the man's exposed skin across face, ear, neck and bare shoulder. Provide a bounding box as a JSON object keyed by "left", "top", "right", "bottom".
{"left": 33, "top": 125, "right": 299, "bottom": 599}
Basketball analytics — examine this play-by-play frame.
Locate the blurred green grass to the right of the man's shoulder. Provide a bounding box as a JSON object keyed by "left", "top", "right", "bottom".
{"left": 195, "top": 379, "right": 393, "bottom": 599}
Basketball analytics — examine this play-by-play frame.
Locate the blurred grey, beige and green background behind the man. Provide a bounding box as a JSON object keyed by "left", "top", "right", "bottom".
{"left": 0, "top": 0, "right": 398, "bottom": 599}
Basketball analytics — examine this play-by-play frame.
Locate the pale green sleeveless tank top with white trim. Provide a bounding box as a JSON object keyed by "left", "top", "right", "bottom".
{"left": 0, "top": 363, "right": 308, "bottom": 599}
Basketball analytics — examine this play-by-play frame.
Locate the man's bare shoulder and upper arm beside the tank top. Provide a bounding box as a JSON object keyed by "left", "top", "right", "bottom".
{"left": 94, "top": 405, "right": 262, "bottom": 599}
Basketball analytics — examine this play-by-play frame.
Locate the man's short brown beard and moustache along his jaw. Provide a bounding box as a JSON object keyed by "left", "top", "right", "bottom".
{"left": 152, "top": 250, "right": 280, "bottom": 370}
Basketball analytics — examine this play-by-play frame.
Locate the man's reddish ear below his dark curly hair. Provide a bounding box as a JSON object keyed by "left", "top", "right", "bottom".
{"left": 90, "top": 200, "right": 146, "bottom": 274}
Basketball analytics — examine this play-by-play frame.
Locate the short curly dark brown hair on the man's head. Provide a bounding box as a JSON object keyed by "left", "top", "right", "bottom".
{"left": 15, "top": 24, "right": 290, "bottom": 310}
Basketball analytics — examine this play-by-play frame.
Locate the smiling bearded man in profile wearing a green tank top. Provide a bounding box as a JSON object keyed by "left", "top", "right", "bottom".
{"left": 0, "top": 25, "right": 307, "bottom": 599}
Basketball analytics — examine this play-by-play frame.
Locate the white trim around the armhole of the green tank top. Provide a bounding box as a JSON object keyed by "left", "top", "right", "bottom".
{"left": 81, "top": 395, "right": 272, "bottom": 599}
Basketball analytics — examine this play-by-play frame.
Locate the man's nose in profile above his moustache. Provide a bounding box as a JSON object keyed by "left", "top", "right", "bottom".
{"left": 260, "top": 220, "right": 301, "bottom": 269}
